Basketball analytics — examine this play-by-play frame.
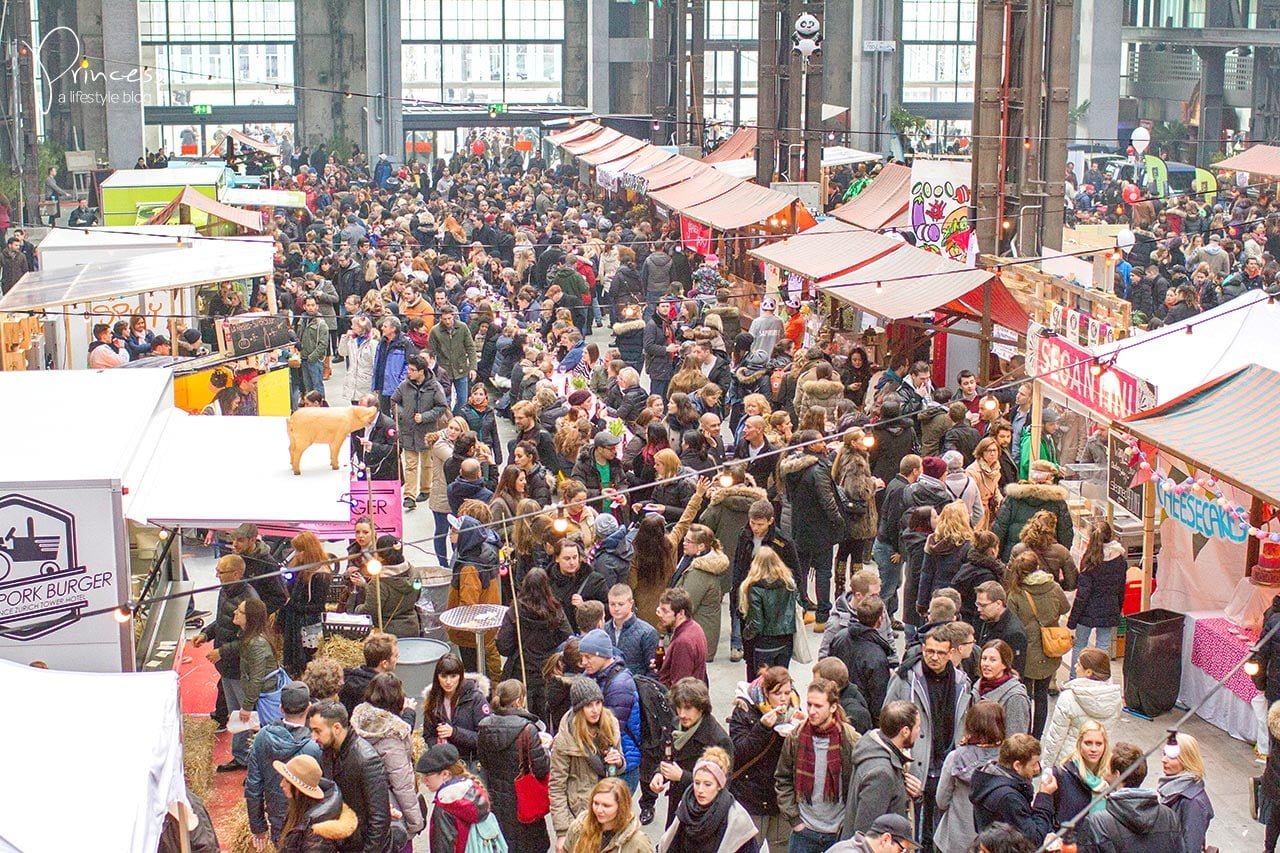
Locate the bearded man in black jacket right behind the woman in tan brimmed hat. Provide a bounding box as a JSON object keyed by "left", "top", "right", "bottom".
{"left": 307, "top": 701, "right": 396, "bottom": 853}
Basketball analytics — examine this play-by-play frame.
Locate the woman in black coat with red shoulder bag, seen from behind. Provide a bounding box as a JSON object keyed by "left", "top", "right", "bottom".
{"left": 476, "top": 679, "right": 552, "bottom": 850}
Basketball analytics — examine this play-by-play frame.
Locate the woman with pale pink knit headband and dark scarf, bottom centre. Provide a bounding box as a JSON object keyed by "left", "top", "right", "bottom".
{"left": 658, "top": 747, "right": 760, "bottom": 853}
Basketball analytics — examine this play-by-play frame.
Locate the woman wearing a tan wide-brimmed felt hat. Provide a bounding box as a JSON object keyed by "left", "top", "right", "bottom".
{"left": 271, "top": 756, "right": 357, "bottom": 853}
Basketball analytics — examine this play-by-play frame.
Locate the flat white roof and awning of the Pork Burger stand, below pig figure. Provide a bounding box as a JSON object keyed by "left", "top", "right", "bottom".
{"left": 0, "top": 368, "right": 351, "bottom": 525}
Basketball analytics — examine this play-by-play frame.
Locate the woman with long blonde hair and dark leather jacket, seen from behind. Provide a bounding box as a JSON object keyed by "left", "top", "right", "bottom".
{"left": 736, "top": 546, "right": 800, "bottom": 681}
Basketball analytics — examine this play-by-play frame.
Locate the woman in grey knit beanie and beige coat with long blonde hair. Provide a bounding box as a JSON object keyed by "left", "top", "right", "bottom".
{"left": 550, "top": 678, "right": 627, "bottom": 840}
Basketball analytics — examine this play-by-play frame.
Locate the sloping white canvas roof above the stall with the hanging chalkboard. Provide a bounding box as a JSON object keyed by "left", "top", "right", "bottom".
{"left": 0, "top": 237, "right": 273, "bottom": 311}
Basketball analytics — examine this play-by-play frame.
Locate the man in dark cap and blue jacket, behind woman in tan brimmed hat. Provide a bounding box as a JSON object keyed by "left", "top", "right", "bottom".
{"left": 244, "top": 681, "right": 320, "bottom": 844}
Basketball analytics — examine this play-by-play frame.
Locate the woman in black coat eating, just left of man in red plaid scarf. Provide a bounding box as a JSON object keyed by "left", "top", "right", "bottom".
{"left": 728, "top": 666, "right": 800, "bottom": 829}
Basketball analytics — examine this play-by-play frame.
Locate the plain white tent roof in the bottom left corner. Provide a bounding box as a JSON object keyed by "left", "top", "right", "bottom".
{"left": 0, "top": 661, "right": 189, "bottom": 853}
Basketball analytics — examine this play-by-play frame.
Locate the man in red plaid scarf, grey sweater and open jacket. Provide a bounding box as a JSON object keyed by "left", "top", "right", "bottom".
{"left": 773, "top": 679, "right": 858, "bottom": 853}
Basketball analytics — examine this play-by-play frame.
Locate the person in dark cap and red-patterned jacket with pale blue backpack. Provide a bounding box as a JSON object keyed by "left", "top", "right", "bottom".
{"left": 417, "top": 743, "right": 508, "bottom": 853}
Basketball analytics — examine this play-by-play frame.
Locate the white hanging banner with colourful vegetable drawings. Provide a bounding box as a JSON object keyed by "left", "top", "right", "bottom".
{"left": 909, "top": 158, "right": 973, "bottom": 264}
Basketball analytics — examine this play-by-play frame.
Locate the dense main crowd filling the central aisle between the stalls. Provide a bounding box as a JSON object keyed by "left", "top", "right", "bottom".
{"left": 157, "top": 150, "right": 1249, "bottom": 853}
